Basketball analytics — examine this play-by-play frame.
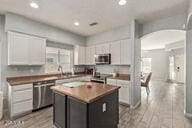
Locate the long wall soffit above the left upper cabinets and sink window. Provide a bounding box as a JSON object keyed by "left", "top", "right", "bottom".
{"left": 5, "top": 13, "right": 86, "bottom": 46}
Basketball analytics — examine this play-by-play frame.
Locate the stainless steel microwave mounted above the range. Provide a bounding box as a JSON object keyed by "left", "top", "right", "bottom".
{"left": 94, "top": 54, "right": 111, "bottom": 65}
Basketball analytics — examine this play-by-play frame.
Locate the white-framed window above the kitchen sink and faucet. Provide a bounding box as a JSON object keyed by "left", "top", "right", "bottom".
{"left": 45, "top": 47, "right": 73, "bottom": 73}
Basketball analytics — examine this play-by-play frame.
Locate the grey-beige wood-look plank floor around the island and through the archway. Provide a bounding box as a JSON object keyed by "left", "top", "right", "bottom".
{"left": 0, "top": 81, "right": 192, "bottom": 128}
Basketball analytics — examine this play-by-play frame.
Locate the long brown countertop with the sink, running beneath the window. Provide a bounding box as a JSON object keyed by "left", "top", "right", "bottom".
{"left": 7, "top": 73, "right": 91, "bottom": 86}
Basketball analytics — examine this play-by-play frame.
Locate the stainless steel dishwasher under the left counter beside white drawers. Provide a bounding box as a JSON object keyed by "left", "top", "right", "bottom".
{"left": 33, "top": 81, "right": 55, "bottom": 110}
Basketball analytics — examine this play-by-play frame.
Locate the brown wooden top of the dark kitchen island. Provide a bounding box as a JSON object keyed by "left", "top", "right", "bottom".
{"left": 51, "top": 82, "right": 120, "bottom": 103}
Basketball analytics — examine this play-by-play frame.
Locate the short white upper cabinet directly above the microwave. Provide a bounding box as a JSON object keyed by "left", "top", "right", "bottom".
{"left": 95, "top": 44, "right": 109, "bottom": 54}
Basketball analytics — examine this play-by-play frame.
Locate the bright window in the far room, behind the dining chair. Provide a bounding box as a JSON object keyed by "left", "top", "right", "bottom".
{"left": 141, "top": 58, "right": 152, "bottom": 73}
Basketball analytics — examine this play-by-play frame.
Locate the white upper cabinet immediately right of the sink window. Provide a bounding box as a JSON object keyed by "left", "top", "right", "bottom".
{"left": 74, "top": 45, "right": 86, "bottom": 65}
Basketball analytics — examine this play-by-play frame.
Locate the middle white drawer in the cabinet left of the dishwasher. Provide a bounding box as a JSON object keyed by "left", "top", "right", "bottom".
{"left": 12, "top": 89, "right": 33, "bottom": 103}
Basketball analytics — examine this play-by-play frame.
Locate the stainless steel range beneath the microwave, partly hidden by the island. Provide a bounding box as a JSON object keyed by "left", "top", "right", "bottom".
{"left": 91, "top": 74, "right": 111, "bottom": 84}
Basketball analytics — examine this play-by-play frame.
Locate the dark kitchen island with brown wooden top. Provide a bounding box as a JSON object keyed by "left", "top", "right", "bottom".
{"left": 51, "top": 82, "right": 119, "bottom": 128}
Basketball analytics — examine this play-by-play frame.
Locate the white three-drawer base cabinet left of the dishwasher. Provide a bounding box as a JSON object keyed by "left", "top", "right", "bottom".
{"left": 9, "top": 84, "right": 33, "bottom": 118}
